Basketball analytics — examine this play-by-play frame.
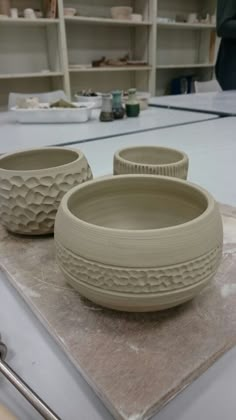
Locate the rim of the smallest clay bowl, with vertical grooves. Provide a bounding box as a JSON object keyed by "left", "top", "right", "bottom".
{"left": 114, "top": 145, "right": 189, "bottom": 168}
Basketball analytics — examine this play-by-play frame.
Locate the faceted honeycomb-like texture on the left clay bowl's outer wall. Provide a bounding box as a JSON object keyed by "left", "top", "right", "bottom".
{"left": 0, "top": 165, "right": 92, "bottom": 235}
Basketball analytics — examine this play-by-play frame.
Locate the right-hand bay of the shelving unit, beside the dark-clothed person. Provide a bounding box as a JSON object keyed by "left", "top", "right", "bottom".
{"left": 156, "top": 0, "right": 217, "bottom": 95}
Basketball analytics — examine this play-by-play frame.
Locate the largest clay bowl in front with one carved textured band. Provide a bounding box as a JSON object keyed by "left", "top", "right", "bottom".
{"left": 55, "top": 175, "right": 223, "bottom": 312}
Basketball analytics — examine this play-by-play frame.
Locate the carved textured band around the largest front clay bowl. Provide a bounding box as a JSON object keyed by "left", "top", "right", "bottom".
{"left": 56, "top": 242, "right": 222, "bottom": 294}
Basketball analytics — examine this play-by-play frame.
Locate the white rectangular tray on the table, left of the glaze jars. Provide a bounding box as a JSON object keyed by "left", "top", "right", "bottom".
{"left": 11, "top": 102, "right": 94, "bottom": 124}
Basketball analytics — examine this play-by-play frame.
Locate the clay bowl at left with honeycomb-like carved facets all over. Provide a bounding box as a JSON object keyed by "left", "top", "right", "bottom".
{"left": 0, "top": 147, "right": 92, "bottom": 235}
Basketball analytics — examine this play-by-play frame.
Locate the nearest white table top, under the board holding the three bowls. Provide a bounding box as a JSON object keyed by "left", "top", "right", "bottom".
{"left": 0, "top": 118, "right": 236, "bottom": 420}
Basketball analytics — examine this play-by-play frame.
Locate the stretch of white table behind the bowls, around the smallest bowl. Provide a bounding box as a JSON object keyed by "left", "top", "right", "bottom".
{"left": 77, "top": 117, "right": 236, "bottom": 206}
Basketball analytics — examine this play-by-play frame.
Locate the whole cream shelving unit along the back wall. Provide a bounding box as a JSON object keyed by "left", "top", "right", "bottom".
{"left": 0, "top": 0, "right": 217, "bottom": 107}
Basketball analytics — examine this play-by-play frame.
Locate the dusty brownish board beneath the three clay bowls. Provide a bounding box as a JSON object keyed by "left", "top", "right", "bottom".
{"left": 0, "top": 206, "right": 236, "bottom": 419}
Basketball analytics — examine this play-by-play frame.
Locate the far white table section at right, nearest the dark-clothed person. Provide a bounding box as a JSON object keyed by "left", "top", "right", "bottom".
{"left": 149, "top": 91, "right": 236, "bottom": 115}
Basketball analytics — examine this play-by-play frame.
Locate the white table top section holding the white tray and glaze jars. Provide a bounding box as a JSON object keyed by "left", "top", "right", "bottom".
{"left": 0, "top": 108, "right": 218, "bottom": 153}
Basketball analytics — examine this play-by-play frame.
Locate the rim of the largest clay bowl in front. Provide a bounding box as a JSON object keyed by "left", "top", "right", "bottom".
{"left": 59, "top": 174, "right": 216, "bottom": 235}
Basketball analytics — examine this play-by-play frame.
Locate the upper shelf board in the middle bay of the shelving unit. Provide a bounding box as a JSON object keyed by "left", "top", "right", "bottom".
{"left": 65, "top": 16, "right": 152, "bottom": 26}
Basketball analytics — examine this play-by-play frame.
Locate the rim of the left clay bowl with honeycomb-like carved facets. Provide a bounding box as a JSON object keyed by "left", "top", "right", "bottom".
{"left": 0, "top": 146, "right": 84, "bottom": 176}
